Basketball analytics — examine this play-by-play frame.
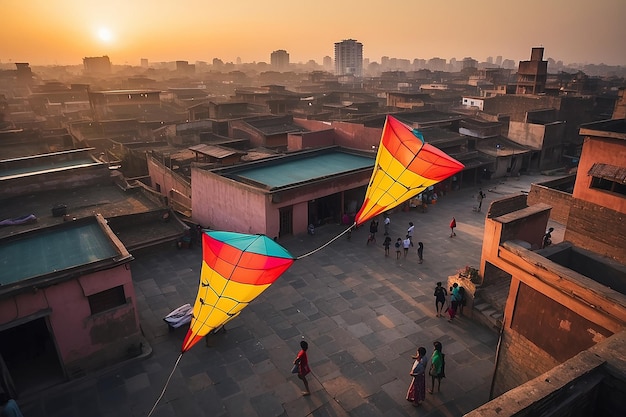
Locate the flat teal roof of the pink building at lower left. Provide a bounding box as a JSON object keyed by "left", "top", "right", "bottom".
{"left": 0, "top": 221, "right": 119, "bottom": 285}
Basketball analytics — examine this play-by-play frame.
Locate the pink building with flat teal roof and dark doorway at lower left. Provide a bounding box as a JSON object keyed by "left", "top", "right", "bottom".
{"left": 0, "top": 215, "right": 143, "bottom": 397}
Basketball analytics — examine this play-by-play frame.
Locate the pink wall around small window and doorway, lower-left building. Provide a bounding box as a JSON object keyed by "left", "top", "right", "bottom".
{"left": 0, "top": 265, "right": 141, "bottom": 377}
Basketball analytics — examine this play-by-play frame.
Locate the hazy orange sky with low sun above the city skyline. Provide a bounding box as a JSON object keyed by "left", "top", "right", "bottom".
{"left": 0, "top": 0, "right": 626, "bottom": 65}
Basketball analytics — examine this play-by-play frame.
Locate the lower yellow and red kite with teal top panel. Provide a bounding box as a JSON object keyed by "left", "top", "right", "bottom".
{"left": 182, "top": 231, "right": 294, "bottom": 353}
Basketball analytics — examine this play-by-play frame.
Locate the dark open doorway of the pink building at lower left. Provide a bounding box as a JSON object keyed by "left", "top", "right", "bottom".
{"left": 0, "top": 317, "right": 65, "bottom": 397}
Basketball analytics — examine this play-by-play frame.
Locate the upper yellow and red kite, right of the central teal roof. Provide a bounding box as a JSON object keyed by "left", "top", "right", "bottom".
{"left": 354, "top": 116, "right": 464, "bottom": 225}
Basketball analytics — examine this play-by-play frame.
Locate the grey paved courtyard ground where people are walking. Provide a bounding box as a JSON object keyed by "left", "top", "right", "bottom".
{"left": 18, "top": 176, "right": 556, "bottom": 417}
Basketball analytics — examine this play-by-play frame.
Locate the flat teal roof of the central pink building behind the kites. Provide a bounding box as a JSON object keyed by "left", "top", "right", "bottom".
{"left": 236, "top": 152, "right": 375, "bottom": 189}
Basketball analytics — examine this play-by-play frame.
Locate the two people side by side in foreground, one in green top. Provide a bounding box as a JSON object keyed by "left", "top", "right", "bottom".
{"left": 406, "top": 341, "right": 446, "bottom": 407}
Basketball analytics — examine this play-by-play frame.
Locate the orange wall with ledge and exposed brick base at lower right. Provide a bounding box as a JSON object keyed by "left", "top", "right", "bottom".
{"left": 488, "top": 242, "right": 626, "bottom": 395}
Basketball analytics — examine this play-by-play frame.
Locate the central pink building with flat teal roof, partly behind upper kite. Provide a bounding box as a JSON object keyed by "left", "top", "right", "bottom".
{"left": 191, "top": 147, "right": 374, "bottom": 237}
